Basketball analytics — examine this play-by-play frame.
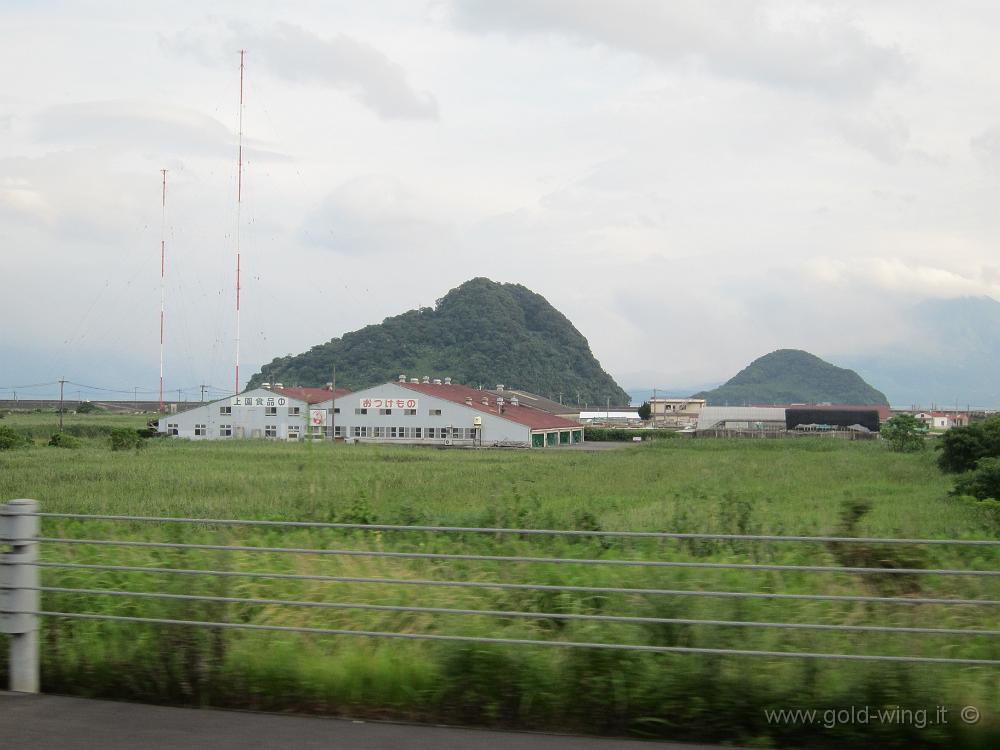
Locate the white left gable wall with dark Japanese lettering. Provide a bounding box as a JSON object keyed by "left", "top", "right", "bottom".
{"left": 158, "top": 388, "right": 309, "bottom": 440}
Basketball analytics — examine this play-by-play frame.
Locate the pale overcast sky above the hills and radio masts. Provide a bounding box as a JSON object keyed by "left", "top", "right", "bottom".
{"left": 0, "top": 0, "right": 1000, "bottom": 406}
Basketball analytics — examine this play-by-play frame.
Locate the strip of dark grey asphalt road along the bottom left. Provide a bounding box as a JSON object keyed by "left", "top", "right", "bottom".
{"left": 0, "top": 692, "right": 731, "bottom": 750}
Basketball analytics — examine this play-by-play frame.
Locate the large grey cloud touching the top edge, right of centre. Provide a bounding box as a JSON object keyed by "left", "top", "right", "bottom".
{"left": 452, "top": 0, "right": 908, "bottom": 96}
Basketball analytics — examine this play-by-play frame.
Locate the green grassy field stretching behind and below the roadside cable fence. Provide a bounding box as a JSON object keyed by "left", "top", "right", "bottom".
{"left": 0, "top": 414, "right": 1000, "bottom": 747}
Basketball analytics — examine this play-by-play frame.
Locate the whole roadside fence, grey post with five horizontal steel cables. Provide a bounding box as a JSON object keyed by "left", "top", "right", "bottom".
{"left": 0, "top": 500, "right": 1000, "bottom": 692}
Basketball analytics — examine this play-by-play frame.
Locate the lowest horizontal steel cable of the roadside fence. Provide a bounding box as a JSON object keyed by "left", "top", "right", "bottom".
{"left": 24, "top": 610, "right": 1000, "bottom": 667}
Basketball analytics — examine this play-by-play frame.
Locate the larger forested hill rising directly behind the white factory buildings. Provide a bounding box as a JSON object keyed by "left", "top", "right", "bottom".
{"left": 247, "top": 278, "right": 628, "bottom": 404}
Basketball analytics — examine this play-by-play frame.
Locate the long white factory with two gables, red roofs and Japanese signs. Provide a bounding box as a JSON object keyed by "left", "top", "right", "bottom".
{"left": 159, "top": 377, "right": 583, "bottom": 448}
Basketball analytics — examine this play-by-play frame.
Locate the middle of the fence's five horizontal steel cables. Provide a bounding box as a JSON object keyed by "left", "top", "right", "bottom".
{"left": 32, "top": 561, "right": 1000, "bottom": 606}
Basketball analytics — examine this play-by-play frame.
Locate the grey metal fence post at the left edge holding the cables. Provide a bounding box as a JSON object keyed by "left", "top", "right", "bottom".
{"left": 0, "top": 500, "right": 39, "bottom": 693}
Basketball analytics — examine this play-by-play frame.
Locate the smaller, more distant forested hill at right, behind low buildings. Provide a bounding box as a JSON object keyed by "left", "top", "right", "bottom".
{"left": 694, "top": 349, "right": 889, "bottom": 406}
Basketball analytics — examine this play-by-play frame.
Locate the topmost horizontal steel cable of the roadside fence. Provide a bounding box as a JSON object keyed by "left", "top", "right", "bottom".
{"left": 32, "top": 513, "right": 1000, "bottom": 547}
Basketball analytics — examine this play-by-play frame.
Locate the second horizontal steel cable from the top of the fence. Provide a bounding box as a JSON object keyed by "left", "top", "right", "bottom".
{"left": 36, "top": 537, "right": 1000, "bottom": 576}
